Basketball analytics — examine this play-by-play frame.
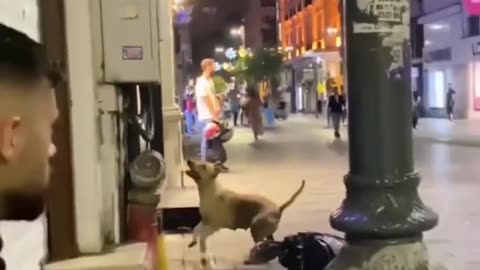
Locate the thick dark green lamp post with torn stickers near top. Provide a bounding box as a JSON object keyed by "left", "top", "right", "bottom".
{"left": 330, "top": 0, "right": 438, "bottom": 270}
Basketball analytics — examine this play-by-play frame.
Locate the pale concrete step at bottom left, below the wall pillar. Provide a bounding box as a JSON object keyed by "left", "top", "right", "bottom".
{"left": 43, "top": 243, "right": 149, "bottom": 270}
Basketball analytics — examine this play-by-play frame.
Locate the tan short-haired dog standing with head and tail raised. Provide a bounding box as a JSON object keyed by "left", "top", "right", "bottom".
{"left": 185, "top": 160, "right": 305, "bottom": 260}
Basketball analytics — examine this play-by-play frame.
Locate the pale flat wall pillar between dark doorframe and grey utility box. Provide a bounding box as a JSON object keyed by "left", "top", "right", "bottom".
{"left": 64, "top": 0, "right": 104, "bottom": 253}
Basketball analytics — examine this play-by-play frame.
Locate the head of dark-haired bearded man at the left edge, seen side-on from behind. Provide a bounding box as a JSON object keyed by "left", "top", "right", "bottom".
{"left": 0, "top": 24, "right": 59, "bottom": 220}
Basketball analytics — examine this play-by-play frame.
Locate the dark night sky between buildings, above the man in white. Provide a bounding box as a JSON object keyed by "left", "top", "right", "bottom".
{"left": 190, "top": 0, "right": 246, "bottom": 70}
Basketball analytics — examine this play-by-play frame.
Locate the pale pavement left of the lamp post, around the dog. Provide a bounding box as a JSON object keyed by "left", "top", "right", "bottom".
{"left": 165, "top": 119, "right": 346, "bottom": 270}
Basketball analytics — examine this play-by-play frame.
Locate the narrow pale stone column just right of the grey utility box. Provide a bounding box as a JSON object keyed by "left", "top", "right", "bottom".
{"left": 158, "top": 0, "right": 183, "bottom": 187}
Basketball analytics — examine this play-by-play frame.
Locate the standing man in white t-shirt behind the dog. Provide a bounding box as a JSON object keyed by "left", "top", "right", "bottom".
{"left": 195, "top": 58, "right": 221, "bottom": 161}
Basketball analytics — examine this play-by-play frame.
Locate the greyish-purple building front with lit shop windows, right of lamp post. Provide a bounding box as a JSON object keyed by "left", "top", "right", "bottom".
{"left": 417, "top": 0, "right": 480, "bottom": 119}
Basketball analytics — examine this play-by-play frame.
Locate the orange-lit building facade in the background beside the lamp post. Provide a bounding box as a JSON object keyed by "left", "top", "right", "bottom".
{"left": 277, "top": 0, "right": 343, "bottom": 112}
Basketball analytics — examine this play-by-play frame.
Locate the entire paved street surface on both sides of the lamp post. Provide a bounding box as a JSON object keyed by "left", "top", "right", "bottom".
{"left": 166, "top": 117, "right": 480, "bottom": 270}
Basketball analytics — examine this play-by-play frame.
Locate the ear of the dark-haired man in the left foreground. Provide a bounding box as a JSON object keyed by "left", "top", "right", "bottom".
{"left": 0, "top": 116, "right": 21, "bottom": 161}
